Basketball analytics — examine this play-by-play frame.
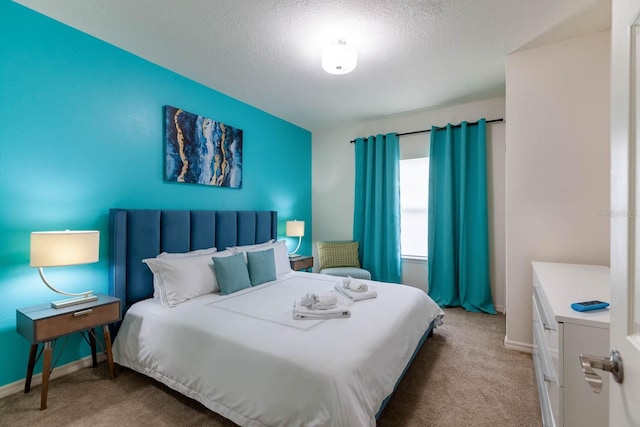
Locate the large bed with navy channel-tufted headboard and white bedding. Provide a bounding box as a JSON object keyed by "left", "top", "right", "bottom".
{"left": 109, "top": 209, "right": 443, "bottom": 426}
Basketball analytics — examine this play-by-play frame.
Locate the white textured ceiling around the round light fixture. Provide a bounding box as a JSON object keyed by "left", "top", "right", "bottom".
{"left": 15, "top": 0, "right": 611, "bottom": 131}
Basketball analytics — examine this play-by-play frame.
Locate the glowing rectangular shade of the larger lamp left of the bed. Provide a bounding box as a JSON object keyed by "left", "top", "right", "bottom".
{"left": 30, "top": 230, "right": 100, "bottom": 267}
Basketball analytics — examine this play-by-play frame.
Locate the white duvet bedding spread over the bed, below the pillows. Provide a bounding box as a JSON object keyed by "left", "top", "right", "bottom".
{"left": 113, "top": 272, "right": 443, "bottom": 427}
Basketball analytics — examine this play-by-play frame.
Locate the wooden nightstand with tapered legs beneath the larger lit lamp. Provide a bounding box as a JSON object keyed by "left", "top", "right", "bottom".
{"left": 16, "top": 295, "right": 120, "bottom": 409}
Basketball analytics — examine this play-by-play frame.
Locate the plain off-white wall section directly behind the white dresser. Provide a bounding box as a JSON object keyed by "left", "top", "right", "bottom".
{"left": 505, "top": 31, "right": 610, "bottom": 349}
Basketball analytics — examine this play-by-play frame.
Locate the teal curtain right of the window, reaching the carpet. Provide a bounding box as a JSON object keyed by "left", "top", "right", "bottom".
{"left": 427, "top": 119, "right": 496, "bottom": 314}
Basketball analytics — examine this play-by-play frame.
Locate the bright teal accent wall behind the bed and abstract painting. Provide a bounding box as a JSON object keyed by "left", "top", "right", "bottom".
{"left": 0, "top": 0, "right": 311, "bottom": 386}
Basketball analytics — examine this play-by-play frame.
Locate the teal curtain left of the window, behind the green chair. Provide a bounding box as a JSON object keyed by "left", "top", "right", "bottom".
{"left": 353, "top": 133, "right": 402, "bottom": 283}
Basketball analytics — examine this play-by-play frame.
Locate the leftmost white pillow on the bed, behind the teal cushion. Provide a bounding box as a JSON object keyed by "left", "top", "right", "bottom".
{"left": 142, "top": 251, "right": 232, "bottom": 307}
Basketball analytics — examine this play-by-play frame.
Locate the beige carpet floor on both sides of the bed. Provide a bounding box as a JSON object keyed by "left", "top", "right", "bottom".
{"left": 0, "top": 309, "right": 541, "bottom": 427}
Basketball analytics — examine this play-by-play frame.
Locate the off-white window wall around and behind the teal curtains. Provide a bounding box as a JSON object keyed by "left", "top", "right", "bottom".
{"left": 312, "top": 98, "right": 505, "bottom": 309}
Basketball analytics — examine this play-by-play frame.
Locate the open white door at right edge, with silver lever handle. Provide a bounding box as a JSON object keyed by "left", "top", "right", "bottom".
{"left": 602, "top": 0, "right": 640, "bottom": 427}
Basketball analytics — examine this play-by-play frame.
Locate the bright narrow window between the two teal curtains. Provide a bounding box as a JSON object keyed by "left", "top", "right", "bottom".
{"left": 400, "top": 157, "right": 429, "bottom": 258}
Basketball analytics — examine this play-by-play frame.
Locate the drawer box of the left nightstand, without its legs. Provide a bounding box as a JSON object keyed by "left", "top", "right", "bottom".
{"left": 17, "top": 300, "right": 120, "bottom": 343}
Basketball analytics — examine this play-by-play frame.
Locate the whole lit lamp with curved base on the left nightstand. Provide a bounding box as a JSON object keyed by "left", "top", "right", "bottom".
{"left": 30, "top": 230, "right": 100, "bottom": 308}
